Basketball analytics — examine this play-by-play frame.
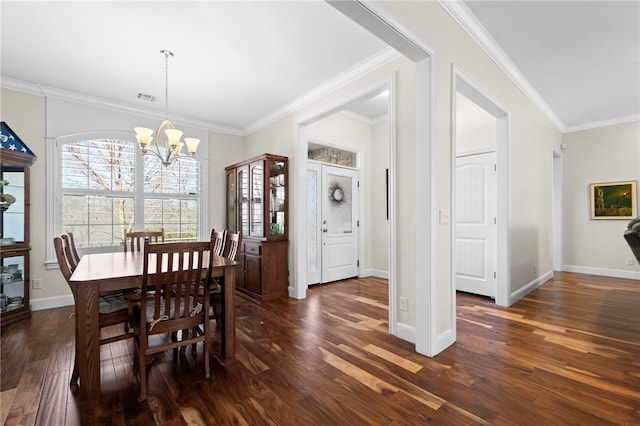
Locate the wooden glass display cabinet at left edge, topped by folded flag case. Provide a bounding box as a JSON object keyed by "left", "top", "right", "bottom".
{"left": 0, "top": 122, "right": 36, "bottom": 327}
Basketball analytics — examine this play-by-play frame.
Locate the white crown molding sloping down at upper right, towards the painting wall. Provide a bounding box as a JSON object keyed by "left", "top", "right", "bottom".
{"left": 438, "top": 0, "right": 566, "bottom": 133}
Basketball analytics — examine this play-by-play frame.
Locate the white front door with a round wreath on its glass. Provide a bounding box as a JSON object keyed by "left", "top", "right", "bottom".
{"left": 319, "top": 165, "right": 358, "bottom": 283}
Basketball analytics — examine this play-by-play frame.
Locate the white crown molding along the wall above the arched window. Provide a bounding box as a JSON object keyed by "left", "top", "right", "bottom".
{"left": 0, "top": 77, "right": 244, "bottom": 136}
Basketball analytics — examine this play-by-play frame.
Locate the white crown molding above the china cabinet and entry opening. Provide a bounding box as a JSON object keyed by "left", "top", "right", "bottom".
{"left": 244, "top": 47, "right": 402, "bottom": 135}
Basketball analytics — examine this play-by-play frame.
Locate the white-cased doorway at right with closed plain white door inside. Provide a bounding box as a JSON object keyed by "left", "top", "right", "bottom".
{"left": 451, "top": 67, "right": 511, "bottom": 312}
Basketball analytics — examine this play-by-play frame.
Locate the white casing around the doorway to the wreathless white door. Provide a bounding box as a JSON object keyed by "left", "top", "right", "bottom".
{"left": 451, "top": 65, "right": 511, "bottom": 312}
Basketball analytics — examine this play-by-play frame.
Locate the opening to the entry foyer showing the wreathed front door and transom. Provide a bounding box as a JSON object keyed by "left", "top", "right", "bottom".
{"left": 296, "top": 76, "right": 394, "bottom": 292}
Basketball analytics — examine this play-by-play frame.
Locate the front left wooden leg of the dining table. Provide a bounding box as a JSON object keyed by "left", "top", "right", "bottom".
{"left": 76, "top": 284, "right": 100, "bottom": 400}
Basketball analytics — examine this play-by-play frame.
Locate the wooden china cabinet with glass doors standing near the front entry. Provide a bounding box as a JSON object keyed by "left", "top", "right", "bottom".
{"left": 225, "top": 154, "right": 289, "bottom": 301}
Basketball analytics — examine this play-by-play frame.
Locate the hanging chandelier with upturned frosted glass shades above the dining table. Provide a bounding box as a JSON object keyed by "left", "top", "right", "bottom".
{"left": 134, "top": 50, "right": 200, "bottom": 166}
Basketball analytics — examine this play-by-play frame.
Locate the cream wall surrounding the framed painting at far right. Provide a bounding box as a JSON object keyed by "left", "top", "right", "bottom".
{"left": 562, "top": 121, "right": 640, "bottom": 279}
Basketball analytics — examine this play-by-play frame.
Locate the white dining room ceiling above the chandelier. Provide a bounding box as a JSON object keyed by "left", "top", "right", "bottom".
{"left": 1, "top": 1, "right": 389, "bottom": 131}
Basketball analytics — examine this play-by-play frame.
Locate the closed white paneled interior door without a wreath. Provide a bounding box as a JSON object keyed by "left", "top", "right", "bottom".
{"left": 455, "top": 152, "right": 498, "bottom": 298}
